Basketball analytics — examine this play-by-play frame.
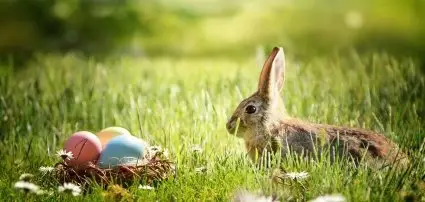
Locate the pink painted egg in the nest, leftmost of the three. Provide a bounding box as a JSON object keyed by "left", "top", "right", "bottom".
{"left": 64, "top": 131, "right": 102, "bottom": 166}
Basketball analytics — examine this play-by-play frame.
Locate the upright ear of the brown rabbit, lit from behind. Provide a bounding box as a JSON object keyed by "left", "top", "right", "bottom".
{"left": 258, "top": 47, "right": 285, "bottom": 100}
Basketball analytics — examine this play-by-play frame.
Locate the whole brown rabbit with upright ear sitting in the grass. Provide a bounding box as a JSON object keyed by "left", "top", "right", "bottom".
{"left": 226, "top": 47, "right": 408, "bottom": 165}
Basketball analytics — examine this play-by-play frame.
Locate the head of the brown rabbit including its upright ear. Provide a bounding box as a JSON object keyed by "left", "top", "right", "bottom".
{"left": 226, "top": 47, "right": 286, "bottom": 137}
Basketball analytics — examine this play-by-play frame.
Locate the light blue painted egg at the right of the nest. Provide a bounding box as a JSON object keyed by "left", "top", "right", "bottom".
{"left": 99, "top": 135, "right": 147, "bottom": 168}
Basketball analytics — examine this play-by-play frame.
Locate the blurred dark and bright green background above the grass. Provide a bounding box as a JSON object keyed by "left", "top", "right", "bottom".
{"left": 0, "top": 0, "right": 425, "bottom": 64}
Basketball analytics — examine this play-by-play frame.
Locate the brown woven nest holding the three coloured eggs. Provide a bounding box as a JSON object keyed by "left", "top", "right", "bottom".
{"left": 55, "top": 152, "right": 175, "bottom": 187}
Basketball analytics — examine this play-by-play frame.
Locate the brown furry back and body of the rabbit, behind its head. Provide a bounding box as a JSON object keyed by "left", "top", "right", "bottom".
{"left": 264, "top": 119, "right": 408, "bottom": 164}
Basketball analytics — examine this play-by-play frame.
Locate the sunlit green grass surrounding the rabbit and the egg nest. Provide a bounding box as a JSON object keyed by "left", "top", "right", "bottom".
{"left": 0, "top": 53, "right": 425, "bottom": 201}
